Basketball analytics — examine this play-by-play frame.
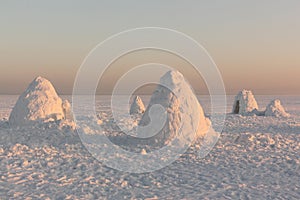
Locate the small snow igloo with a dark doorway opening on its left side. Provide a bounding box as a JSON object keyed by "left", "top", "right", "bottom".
{"left": 232, "top": 90, "right": 258, "bottom": 115}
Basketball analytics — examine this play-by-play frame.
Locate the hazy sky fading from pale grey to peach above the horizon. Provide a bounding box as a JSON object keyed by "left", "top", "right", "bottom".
{"left": 0, "top": 0, "right": 300, "bottom": 94}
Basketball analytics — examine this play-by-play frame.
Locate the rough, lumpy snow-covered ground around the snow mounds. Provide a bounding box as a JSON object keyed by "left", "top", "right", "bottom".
{"left": 0, "top": 96, "right": 300, "bottom": 199}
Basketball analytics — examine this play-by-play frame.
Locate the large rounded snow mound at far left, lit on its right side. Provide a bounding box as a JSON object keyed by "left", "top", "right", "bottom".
{"left": 9, "top": 77, "right": 72, "bottom": 126}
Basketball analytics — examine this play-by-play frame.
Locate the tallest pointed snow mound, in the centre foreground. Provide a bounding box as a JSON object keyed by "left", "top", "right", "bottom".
{"left": 139, "top": 71, "right": 211, "bottom": 144}
